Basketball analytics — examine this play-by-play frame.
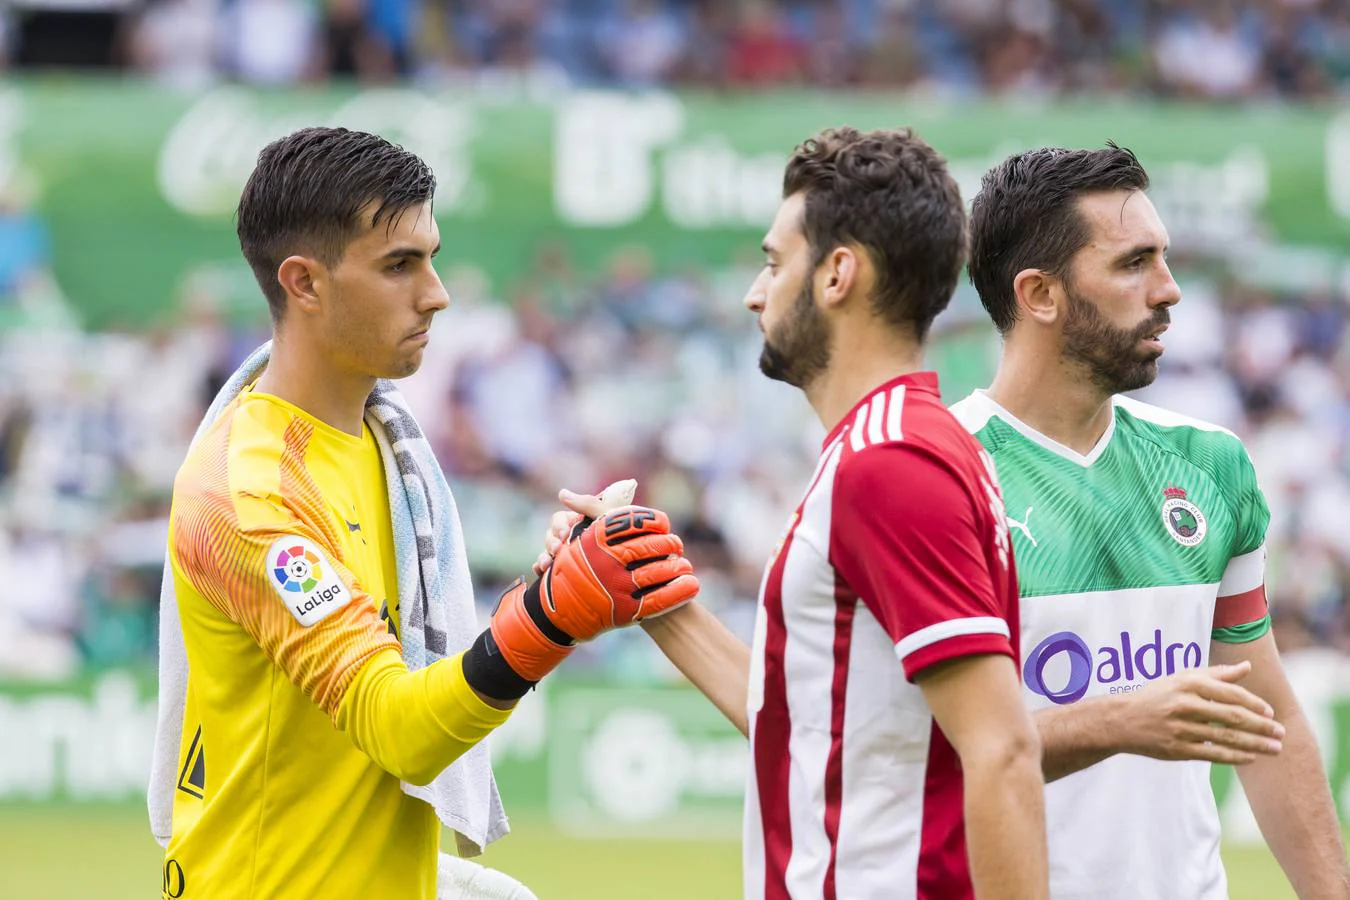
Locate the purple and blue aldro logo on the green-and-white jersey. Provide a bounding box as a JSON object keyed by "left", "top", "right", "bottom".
{"left": 1022, "top": 629, "right": 1200, "bottom": 704}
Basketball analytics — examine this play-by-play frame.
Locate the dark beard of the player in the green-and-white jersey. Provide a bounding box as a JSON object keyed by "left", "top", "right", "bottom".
{"left": 1064, "top": 283, "right": 1172, "bottom": 394}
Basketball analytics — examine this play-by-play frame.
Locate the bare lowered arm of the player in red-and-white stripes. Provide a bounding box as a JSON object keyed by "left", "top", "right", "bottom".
{"left": 918, "top": 654, "right": 1050, "bottom": 900}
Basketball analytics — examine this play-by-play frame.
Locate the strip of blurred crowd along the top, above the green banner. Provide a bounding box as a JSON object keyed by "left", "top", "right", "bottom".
{"left": 0, "top": 0, "right": 1350, "bottom": 100}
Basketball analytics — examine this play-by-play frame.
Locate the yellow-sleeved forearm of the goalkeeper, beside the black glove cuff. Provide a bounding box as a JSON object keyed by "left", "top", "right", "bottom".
{"left": 336, "top": 650, "right": 510, "bottom": 784}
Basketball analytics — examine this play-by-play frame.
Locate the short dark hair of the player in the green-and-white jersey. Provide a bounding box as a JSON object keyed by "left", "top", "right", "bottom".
{"left": 969, "top": 142, "right": 1149, "bottom": 333}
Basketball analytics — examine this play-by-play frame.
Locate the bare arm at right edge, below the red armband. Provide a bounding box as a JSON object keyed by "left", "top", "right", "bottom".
{"left": 1211, "top": 631, "right": 1350, "bottom": 900}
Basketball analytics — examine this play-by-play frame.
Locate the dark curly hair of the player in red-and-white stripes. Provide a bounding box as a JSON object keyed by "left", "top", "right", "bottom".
{"left": 783, "top": 127, "right": 965, "bottom": 340}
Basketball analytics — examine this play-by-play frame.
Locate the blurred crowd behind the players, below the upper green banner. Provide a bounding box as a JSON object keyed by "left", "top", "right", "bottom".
{"left": 0, "top": 209, "right": 1350, "bottom": 677}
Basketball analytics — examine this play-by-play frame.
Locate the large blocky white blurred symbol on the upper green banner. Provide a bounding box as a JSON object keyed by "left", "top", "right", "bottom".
{"left": 554, "top": 92, "right": 684, "bottom": 228}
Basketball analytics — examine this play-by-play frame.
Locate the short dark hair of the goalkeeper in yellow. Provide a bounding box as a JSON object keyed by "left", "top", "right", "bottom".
{"left": 236, "top": 128, "right": 436, "bottom": 321}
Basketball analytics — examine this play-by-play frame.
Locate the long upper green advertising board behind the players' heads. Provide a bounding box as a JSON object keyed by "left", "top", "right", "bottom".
{"left": 0, "top": 78, "right": 1350, "bottom": 327}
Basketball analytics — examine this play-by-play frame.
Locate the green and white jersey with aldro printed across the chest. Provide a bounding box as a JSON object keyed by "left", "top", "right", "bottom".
{"left": 952, "top": 391, "right": 1270, "bottom": 900}
